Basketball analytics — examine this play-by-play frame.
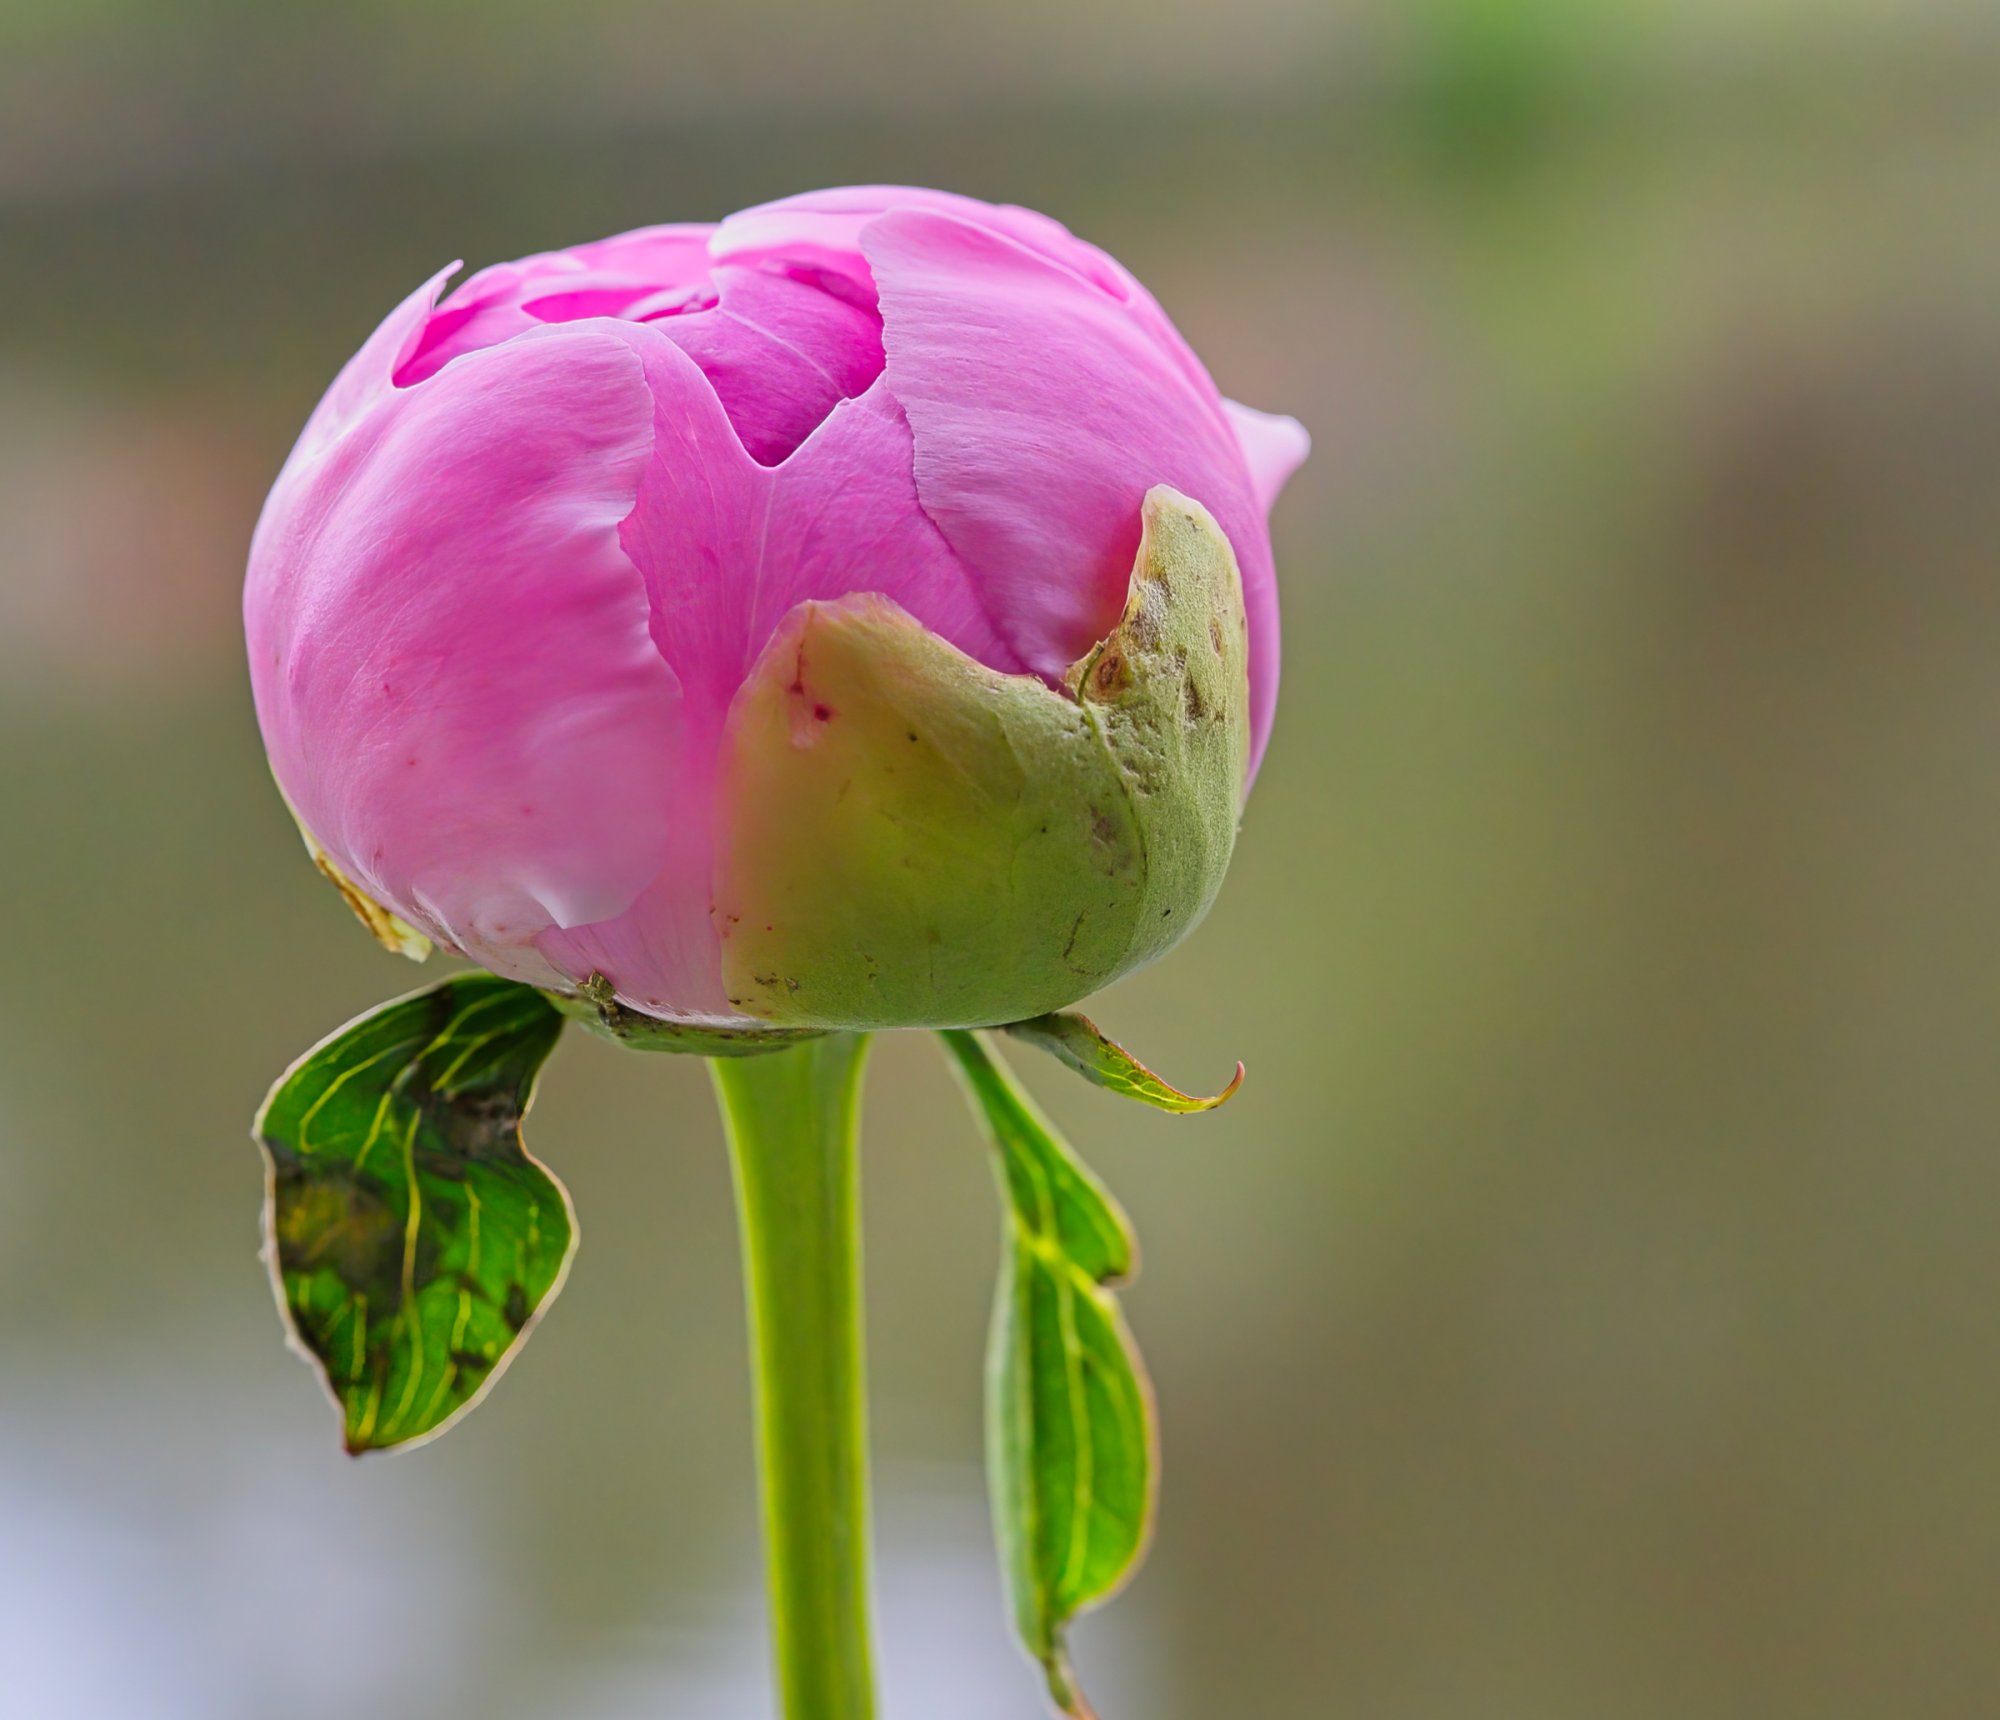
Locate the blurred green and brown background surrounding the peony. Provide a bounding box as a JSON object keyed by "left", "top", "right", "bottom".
{"left": 0, "top": 0, "right": 2000, "bottom": 1720}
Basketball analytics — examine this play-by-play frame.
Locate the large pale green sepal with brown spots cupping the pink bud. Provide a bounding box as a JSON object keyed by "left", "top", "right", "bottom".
{"left": 714, "top": 486, "right": 1250, "bottom": 1030}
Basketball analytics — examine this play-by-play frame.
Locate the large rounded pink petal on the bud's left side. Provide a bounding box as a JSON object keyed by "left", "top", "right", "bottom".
{"left": 244, "top": 322, "right": 682, "bottom": 980}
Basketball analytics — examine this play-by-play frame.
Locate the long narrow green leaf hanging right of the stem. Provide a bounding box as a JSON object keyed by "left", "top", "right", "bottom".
{"left": 940, "top": 1030, "right": 1158, "bottom": 1720}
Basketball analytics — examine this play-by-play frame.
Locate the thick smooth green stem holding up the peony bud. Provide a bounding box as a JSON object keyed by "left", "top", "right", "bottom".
{"left": 710, "top": 1034, "right": 874, "bottom": 1720}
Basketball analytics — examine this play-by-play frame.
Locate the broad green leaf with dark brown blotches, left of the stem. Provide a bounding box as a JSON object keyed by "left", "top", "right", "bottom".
{"left": 252, "top": 974, "right": 576, "bottom": 1452}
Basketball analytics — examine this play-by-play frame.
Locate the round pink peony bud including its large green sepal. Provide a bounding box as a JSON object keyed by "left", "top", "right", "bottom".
{"left": 244, "top": 188, "right": 1306, "bottom": 1028}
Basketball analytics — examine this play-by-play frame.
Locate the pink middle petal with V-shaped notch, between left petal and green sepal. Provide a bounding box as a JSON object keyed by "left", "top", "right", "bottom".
{"left": 540, "top": 324, "right": 1020, "bottom": 1022}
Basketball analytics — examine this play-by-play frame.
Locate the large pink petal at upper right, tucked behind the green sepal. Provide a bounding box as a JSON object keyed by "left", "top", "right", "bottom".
{"left": 862, "top": 210, "right": 1278, "bottom": 770}
